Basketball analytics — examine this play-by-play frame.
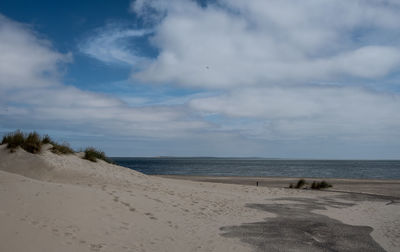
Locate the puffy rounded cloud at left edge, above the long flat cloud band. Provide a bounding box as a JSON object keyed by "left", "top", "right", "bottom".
{"left": 0, "top": 14, "right": 72, "bottom": 90}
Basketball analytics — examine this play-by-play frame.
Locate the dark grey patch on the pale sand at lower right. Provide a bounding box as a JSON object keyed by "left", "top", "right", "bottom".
{"left": 221, "top": 198, "right": 385, "bottom": 252}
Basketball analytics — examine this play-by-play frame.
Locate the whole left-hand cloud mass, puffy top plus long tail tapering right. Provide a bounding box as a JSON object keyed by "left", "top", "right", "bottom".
{"left": 0, "top": 16, "right": 208, "bottom": 138}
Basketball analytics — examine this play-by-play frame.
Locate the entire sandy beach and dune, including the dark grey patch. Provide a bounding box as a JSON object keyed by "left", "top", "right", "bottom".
{"left": 0, "top": 145, "right": 400, "bottom": 251}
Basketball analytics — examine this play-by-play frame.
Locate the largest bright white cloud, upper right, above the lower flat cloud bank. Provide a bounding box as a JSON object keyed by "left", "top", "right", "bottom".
{"left": 132, "top": 0, "right": 400, "bottom": 88}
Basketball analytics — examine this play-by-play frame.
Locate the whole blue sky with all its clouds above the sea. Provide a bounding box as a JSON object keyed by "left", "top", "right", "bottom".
{"left": 0, "top": 0, "right": 400, "bottom": 159}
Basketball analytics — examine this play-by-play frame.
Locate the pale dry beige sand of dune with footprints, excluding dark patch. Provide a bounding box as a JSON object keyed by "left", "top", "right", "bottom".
{"left": 0, "top": 145, "right": 400, "bottom": 251}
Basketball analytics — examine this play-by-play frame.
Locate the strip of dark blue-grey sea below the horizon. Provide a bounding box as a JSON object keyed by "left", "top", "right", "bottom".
{"left": 112, "top": 157, "right": 400, "bottom": 179}
